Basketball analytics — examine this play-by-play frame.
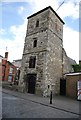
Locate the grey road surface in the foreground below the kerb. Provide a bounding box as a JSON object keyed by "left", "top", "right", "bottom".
{"left": 2, "top": 88, "right": 79, "bottom": 118}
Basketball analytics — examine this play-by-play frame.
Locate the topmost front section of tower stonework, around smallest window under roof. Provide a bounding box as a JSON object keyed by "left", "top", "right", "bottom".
{"left": 27, "top": 9, "right": 49, "bottom": 36}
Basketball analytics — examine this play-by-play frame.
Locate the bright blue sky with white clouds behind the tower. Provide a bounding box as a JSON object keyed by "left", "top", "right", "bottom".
{"left": 0, "top": 0, "right": 81, "bottom": 63}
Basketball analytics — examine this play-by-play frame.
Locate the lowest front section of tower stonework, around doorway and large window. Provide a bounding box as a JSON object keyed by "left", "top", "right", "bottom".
{"left": 21, "top": 51, "right": 46, "bottom": 94}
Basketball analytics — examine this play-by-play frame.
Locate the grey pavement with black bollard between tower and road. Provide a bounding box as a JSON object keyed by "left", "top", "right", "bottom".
{"left": 2, "top": 89, "right": 81, "bottom": 116}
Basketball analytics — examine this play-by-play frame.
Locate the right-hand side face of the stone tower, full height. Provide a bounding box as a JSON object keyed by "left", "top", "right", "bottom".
{"left": 44, "top": 11, "right": 63, "bottom": 95}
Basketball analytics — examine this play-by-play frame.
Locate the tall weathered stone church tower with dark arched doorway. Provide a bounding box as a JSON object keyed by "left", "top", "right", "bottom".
{"left": 19, "top": 6, "right": 73, "bottom": 96}
